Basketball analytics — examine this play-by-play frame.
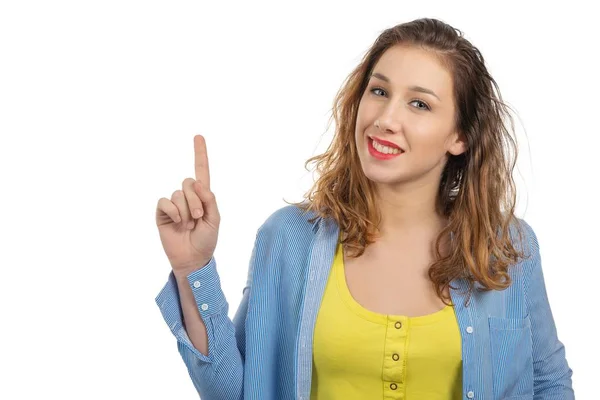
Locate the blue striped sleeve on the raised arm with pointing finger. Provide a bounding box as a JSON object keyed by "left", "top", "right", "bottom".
{"left": 155, "top": 250, "right": 254, "bottom": 400}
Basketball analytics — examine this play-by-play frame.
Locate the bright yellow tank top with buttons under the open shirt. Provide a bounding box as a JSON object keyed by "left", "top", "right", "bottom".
{"left": 310, "top": 239, "right": 462, "bottom": 400}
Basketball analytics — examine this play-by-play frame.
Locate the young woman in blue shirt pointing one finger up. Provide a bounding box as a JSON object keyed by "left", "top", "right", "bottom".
{"left": 156, "top": 19, "right": 574, "bottom": 400}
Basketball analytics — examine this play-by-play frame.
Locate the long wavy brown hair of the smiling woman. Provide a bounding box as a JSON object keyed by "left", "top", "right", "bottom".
{"left": 286, "top": 18, "right": 524, "bottom": 304}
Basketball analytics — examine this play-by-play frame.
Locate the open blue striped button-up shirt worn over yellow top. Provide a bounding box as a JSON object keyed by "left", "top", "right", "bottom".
{"left": 156, "top": 205, "right": 574, "bottom": 400}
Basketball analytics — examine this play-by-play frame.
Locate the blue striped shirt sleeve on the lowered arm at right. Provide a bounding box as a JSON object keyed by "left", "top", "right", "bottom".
{"left": 523, "top": 221, "right": 575, "bottom": 400}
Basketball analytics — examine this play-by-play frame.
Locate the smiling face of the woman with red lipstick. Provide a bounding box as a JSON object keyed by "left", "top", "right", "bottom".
{"left": 355, "top": 45, "right": 465, "bottom": 191}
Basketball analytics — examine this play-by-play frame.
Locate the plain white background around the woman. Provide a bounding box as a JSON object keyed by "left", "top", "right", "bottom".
{"left": 0, "top": 0, "right": 600, "bottom": 399}
